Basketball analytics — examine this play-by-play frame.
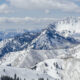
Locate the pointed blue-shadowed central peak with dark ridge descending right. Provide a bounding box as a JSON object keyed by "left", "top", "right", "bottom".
{"left": 30, "top": 24, "right": 80, "bottom": 50}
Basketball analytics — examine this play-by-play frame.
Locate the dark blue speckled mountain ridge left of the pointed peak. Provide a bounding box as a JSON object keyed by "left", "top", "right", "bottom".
{"left": 0, "top": 32, "right": 39, "bottom": 57}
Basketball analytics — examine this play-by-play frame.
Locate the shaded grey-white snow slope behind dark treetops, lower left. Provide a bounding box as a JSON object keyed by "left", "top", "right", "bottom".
{"left": 0, "top": 66, "right": 54, "bottom": 80}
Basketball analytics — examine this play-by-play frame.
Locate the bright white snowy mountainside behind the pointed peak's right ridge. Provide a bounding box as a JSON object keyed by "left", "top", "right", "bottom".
{"left": 53, "top": 17, "right": 80, "bottom": 40}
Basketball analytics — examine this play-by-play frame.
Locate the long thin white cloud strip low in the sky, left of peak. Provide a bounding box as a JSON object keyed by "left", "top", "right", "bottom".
{"left": 0, "top": 17, "right": 55, "bottom": 23}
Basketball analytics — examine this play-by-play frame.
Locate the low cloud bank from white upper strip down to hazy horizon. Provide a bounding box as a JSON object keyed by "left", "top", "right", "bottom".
{"left": 0, "top": 17, "right": 55, "bottom": 30}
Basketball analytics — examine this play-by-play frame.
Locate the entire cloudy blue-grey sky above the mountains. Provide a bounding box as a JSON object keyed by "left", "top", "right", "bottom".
{"left": 0, "top": 0, "right": 80, "bottom": 30}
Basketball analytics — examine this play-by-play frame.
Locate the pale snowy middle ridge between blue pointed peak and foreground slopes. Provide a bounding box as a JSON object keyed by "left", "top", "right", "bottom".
{"left": 0, "top": 45, "right": 80, "bottom": 68}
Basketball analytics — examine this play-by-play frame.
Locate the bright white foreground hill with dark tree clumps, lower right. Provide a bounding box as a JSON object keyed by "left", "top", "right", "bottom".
{"left": 35, "top": 58, "right": 80, "bottom": 80}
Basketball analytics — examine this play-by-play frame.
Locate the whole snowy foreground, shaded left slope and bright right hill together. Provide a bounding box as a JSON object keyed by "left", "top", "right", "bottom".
{"left": 0, "top": 57, "right": 80, "bottom": 80}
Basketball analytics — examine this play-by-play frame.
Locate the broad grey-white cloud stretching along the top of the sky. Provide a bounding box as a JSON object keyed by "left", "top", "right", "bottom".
{"left": 8, "top": 0, "right": 80, "bottom": 12}
